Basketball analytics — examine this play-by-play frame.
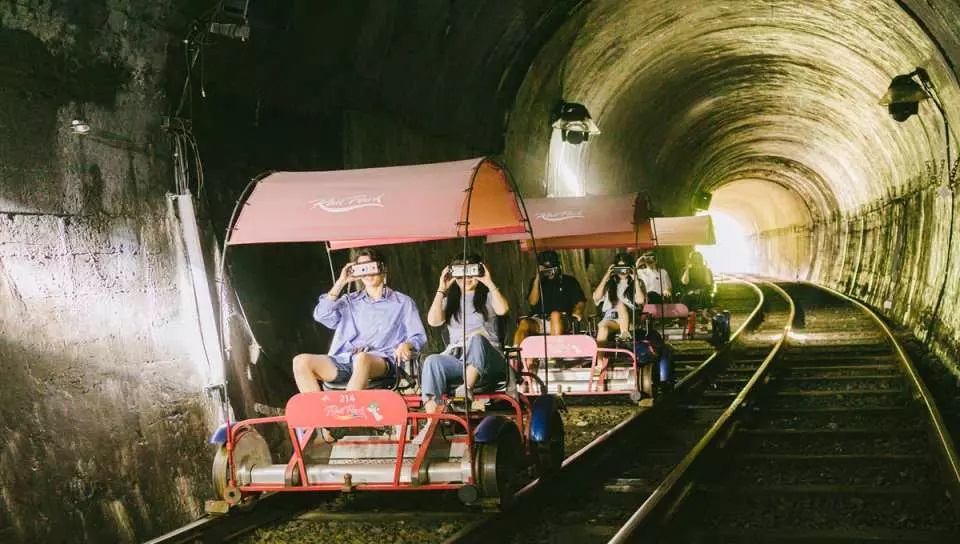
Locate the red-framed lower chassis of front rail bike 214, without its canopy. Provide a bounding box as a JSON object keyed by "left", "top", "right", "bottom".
{"left": 213, "top": 389, "right": 562, "bottom": 505}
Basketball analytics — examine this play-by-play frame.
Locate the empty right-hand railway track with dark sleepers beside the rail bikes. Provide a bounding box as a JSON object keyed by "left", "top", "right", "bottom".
{"left": 611, "top": 284, "right": 960, "bottom": 543}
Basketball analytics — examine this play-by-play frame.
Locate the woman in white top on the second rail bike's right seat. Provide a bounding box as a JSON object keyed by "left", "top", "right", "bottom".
{"left": 593, "top": 253, "right": 645, "bottom": 368}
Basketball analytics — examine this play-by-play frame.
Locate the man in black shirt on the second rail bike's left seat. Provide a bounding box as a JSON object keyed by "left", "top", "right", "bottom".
{"left": 513, "top": 251, "right": 586, "bottom": 346}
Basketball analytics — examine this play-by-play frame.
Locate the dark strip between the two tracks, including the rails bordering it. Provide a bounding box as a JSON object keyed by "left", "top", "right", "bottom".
{"left": 448, "top": 278, "right": 789, "bottom": 543}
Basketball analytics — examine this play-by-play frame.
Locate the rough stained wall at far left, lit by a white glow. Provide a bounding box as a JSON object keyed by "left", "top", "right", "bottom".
{"left": 0, "top": 0, "right": 213, "bottom": 542}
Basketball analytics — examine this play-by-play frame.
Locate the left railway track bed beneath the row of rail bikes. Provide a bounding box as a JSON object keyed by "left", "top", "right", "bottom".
{"left": 142, "top": 282, "right": 759, "bottom": 544}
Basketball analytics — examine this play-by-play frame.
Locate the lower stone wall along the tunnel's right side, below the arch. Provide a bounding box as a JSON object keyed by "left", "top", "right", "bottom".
{"left": 753, "top": 164, "right": 960, "bottom": 378}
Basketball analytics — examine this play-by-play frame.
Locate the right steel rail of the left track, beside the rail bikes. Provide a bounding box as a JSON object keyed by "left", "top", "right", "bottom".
{"left": 443, "top": 276, "right": 764, "bottom": 544}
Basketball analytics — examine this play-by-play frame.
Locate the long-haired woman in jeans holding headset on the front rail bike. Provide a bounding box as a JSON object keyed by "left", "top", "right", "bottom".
{"left": 420, "top": 255, "right": 510, "bottom": 420}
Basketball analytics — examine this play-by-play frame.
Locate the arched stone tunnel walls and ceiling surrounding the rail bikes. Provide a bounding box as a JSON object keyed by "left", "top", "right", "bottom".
{"left": 0, "top": 0, "right": 960, "bottom": 542}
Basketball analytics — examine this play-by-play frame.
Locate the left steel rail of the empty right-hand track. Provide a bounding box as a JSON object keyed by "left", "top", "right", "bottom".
{"left": 609, "top": 282, "right": 796, "bottom": 544}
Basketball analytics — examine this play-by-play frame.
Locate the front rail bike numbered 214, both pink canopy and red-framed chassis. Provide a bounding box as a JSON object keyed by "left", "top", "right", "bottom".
{"left": 211, "top": 158, "right": 563, "bottom": 506}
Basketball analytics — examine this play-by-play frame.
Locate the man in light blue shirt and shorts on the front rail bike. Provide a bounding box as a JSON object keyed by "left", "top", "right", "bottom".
{"left": 293, "top": 249, "right": 427, "bottom": 393}
